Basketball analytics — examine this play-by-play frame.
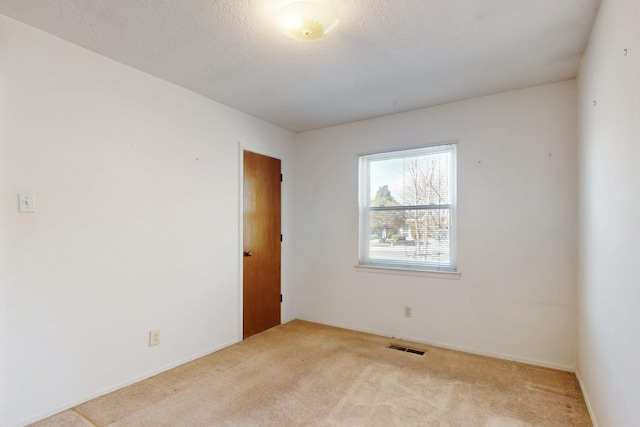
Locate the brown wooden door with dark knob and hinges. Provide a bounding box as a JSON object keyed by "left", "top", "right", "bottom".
{"left": 242, "top": 151, "right": 281, "bottom": 338}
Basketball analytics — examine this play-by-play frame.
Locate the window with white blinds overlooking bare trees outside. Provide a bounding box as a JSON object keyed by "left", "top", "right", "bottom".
{"left": 360, "top": 143, "right": 456, "bottom": 271}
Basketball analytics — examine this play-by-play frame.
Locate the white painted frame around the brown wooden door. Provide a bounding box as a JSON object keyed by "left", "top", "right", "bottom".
{"left": 237, "top": 142, "right": 285, "bottom": 342}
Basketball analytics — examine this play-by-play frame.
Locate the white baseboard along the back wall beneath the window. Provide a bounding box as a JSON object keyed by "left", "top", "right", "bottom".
{"left": 298, "top": 317, "right": 576, "bottom": 372}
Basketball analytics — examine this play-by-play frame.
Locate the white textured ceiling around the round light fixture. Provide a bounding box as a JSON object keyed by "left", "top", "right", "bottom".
{"left": 0, "top": 0, "right": 600, "bottom": 132}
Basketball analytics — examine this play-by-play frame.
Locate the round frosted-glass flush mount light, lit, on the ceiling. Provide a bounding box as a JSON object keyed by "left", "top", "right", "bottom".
{"left": 278, "top": 0, "right": 338, "bottom": 41}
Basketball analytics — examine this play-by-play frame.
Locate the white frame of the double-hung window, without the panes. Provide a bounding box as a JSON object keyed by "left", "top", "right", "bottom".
{"left": 358, "top": 141, "right": 458, "bottom": 273}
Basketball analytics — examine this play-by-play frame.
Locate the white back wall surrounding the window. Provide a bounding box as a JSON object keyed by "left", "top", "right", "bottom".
{"left": 295, "top": 81, "right": 577, "bottom": 369}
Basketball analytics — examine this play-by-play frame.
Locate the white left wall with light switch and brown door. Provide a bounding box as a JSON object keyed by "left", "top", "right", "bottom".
{"left": 0, "top": 17, "right": 293, "bottom": 426}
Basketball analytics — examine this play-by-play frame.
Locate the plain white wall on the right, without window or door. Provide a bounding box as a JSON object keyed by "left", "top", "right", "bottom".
{"left": 578, "top": 0, "right": 640, "bottom": 427}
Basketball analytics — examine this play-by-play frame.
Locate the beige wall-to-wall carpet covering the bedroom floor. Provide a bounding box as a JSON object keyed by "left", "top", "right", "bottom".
{"left": 32, "top": 320, "right": 591, "bottom": 427}
